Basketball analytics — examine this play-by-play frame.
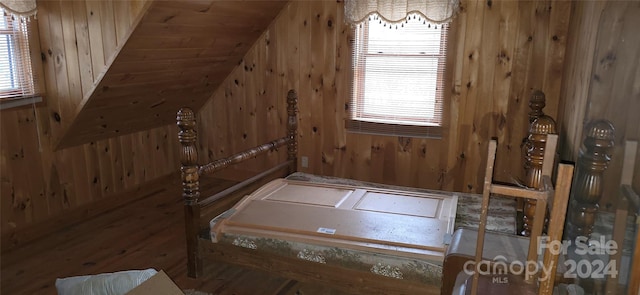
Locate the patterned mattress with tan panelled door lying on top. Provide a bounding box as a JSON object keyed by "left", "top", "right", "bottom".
{"left": 210, "top": 173, "right": 515, "bottom": 286}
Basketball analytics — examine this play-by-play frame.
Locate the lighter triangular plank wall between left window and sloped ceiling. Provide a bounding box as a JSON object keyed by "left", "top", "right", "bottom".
{"left": 37, "top": 0, "right": 150, "bottom": 143}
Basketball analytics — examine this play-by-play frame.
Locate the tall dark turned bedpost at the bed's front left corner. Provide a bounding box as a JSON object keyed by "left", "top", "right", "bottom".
{"left": 176, "top": 108, "right": 202, "bottom": 278}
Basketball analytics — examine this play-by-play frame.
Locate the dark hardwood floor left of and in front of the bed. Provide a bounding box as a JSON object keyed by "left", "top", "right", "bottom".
{"left": 0, "top": 175, "right": 344, "bottom": 295}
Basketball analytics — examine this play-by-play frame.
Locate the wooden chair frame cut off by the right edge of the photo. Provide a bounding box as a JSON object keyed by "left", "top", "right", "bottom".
{"left": 606, "top": 141, "right": 640, "bottom": 295}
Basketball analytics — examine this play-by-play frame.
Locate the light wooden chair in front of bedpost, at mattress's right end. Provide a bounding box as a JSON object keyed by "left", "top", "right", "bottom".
{"left": 445, "top": 135, "right": 573, "bottom": 295}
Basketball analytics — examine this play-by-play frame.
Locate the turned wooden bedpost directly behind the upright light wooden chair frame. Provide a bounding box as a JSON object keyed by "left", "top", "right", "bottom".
{"left": 520, "top": 115, "right": 557, "bottom": 237}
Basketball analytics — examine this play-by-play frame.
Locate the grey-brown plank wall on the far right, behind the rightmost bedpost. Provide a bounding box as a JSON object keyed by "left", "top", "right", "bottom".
{"left": 560, "top": 1, "right": 640, "bottom": 209}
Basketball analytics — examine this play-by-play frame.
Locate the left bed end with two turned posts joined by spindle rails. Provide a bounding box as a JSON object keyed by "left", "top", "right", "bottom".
{"left": 176, "top": 90, "right": 298, "bottom": 277}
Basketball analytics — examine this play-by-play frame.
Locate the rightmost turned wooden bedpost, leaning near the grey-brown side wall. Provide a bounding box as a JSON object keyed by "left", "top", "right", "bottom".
{"left": 567, "top": 120, "right": 615, "bottom": 240}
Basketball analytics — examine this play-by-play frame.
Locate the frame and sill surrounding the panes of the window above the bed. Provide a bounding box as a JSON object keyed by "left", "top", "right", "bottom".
{"left": 345, "top": 16, "right": 452, "bottom": 138}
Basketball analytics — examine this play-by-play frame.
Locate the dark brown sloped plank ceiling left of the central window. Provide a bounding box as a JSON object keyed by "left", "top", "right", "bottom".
{"left": 57, "top": 0, "right": 286, "bottom": 149}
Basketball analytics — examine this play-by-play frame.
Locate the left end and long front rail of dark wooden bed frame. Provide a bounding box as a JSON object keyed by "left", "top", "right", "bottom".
{"left": 177, "top": 90, "right": 460, "bottom": 295}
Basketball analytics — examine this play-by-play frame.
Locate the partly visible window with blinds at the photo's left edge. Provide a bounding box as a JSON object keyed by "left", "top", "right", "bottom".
{"left": 0, "top": 13, "right": 40, "bottom": 109}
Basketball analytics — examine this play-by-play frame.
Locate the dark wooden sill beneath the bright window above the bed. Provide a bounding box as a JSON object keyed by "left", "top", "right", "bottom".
{"left": 345, "top": 120, "right": 442, "bottom": 139}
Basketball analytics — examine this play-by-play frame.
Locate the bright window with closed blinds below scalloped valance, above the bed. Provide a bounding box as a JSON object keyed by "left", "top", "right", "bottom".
{"left": 347, "top": 15, "right": 448, "bottom": 137}
